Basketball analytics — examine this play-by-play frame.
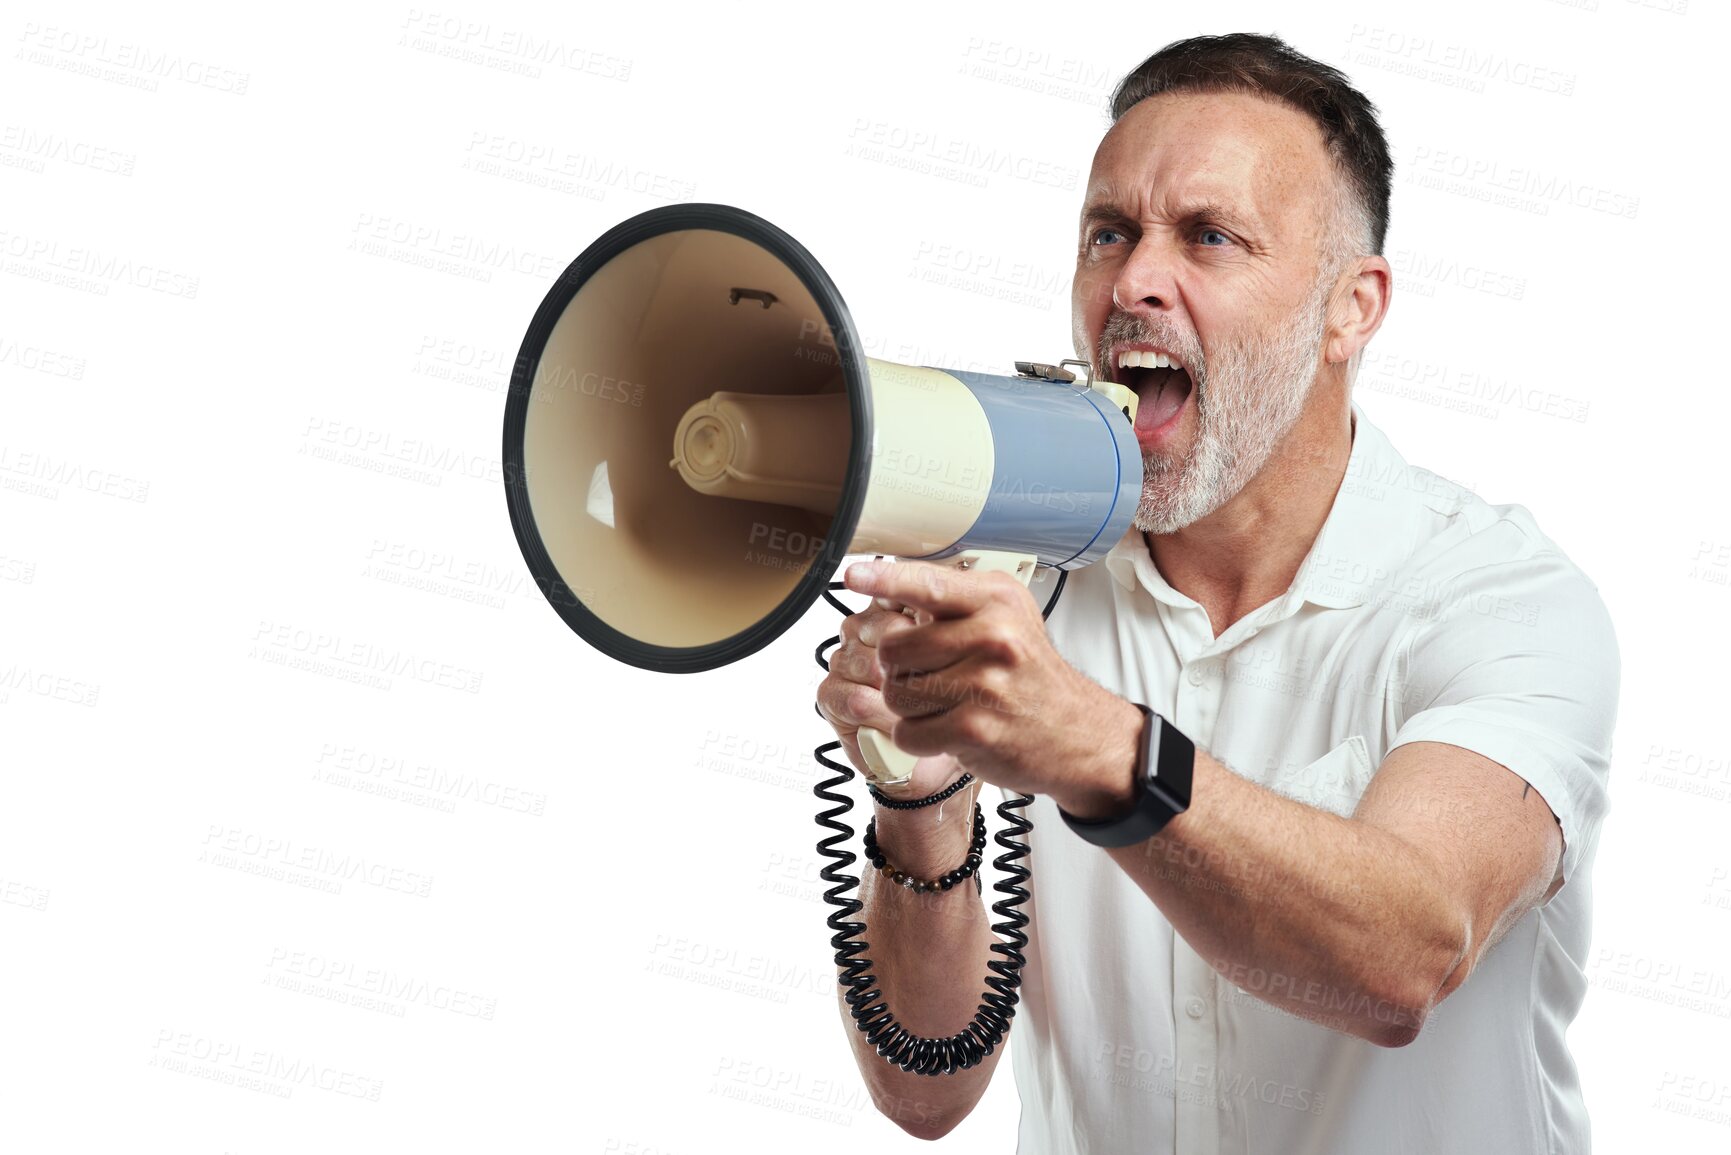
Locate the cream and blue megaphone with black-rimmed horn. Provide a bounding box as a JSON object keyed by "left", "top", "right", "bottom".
{"left": 502, "top": 204, "right": 1142, "bottom": 788}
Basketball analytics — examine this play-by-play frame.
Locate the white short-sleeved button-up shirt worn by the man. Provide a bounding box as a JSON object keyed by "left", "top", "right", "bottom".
{"left": 1011, "top": 403, "right": 1618, "bottom": 1155}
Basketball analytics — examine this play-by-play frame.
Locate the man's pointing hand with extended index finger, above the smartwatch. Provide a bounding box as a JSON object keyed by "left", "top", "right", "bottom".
{"left": 846, "top": 561, "right": 1142, "bottom": 814}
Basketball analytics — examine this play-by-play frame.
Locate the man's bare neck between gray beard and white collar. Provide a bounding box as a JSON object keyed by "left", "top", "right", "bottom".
{"left": 1142, "top": 381, "right": 1352, "bottom": 637}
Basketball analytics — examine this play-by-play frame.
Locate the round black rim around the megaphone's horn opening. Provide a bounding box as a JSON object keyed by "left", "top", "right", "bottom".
{"left": 502, "top": 204, "right": 871, "bottom": 674}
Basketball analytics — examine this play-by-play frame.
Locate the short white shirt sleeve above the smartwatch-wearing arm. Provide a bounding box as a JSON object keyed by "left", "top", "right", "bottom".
{"left": 1388, "top": 551, "right": 1622, "bottom": 881}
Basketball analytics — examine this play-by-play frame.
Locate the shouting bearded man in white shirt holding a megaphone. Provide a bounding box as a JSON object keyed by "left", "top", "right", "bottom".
{"left": 819, "top": 35, "right": 1618, "bottom": 1155}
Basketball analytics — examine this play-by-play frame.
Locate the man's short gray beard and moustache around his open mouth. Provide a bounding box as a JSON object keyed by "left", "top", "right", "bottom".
{"left": 1101, "top": 279, "right": 1331, "bottom": 533}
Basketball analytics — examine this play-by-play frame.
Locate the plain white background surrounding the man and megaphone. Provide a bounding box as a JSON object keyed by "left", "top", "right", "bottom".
{"left": 0, "top": 0, "right": 1731, "bottom": 1153}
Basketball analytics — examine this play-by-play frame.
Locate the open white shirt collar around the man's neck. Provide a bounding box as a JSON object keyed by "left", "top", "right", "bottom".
{"left": 1103, "top": 402, "right": 1459, "bottom": 616}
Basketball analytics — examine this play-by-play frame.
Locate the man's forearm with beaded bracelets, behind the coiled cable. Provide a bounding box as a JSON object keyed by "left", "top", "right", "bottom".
{"left": 840, "top": 786, "right": 1002, "bottom": 1139}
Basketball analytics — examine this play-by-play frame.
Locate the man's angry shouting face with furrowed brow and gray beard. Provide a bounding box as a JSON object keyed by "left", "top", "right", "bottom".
{"left": 1071, "top": 94, "right": 1335, "bottom": 533}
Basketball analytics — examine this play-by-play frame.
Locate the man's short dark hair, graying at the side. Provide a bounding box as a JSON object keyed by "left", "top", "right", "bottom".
{"left": 1111, "top": 33, "right": 1395, "bottom": 261}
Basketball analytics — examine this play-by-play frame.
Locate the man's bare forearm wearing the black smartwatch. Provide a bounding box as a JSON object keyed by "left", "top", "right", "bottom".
{"left": 1058, "top": 707, "right": 1464, "bottom": 1044}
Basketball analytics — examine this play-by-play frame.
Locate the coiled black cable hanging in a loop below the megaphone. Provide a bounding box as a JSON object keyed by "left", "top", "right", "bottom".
{"left": 812, "top": 570, "right": 1070, "bottom": 1075}
